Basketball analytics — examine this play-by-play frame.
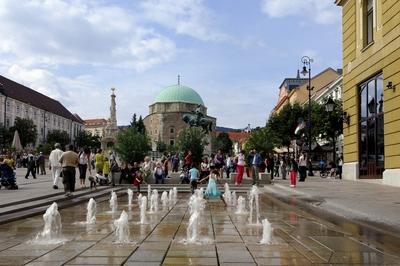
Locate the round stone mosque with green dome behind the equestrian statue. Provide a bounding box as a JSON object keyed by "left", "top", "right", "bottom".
{"left": 143, "top": 80, "right": 217, "bottom": 153}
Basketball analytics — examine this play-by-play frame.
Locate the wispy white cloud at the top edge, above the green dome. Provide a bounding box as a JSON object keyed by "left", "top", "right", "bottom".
{"left": 141, "top": 0, "right": 230, "bottom": 41}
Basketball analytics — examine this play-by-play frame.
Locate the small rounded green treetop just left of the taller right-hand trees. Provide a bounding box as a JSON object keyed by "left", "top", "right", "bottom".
{"left": 245, "top": 127, "right": 278, "bottom": 152}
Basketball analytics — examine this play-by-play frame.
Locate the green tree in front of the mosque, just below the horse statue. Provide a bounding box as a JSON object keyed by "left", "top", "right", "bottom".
{"left": 177, "top": 127, "right": 208, "bottom": 163}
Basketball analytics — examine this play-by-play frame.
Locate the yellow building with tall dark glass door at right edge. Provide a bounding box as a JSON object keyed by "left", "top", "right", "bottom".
{"left": 336, "top": 0, "right": 400, "bottom": 186}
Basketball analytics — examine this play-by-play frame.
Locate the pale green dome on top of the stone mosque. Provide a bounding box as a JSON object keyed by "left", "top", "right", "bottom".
{"left": 155, "top": 84, "right": 204, "bottom": 106}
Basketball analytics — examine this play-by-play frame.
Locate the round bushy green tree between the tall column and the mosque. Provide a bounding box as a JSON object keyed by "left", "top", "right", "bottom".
{"left": 115, "top": 127, "right": 151, "bottom": 163}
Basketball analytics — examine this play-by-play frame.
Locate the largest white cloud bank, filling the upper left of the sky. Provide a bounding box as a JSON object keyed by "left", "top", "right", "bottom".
{"left": 0, "top": 0, "right": 176, "bottom": 71}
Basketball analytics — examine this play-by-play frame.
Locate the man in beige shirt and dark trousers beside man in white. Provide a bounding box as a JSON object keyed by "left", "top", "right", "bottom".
{"left": 59, "top": 144, "right": 79, "bottom": 197}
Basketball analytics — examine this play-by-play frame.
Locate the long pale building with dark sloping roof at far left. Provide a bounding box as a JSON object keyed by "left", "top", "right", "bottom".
{"left": 0, "top": 76, "right": 84, "bottom": 145}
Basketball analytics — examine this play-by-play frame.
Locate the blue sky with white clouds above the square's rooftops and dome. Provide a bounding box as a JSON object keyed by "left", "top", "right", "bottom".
{"left": 0, "top": 0, "right": 342, "bottom": 128}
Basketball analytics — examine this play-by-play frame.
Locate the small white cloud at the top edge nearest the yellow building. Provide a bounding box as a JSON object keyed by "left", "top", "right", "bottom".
{"left": 261, "top": 0, "right": 341, "bottom": 24}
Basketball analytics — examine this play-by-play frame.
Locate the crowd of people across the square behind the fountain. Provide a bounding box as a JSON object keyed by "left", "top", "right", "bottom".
{"left": 0, "top": 143, "right": 343, "bottom": 196}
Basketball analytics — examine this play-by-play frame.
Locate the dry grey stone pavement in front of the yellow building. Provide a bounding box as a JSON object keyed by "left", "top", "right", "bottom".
{"left": 264, "top": 176, "right": 400, "bottom": 235}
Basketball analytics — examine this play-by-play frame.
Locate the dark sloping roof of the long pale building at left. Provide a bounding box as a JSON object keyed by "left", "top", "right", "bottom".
{"left": 0, "top": 75, "right": 82, "bottom": 123}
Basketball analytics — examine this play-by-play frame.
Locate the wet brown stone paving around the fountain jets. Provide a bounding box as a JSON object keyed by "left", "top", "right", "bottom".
{"left": 0, "top": 190, "right": 400, "bottom": 266}
